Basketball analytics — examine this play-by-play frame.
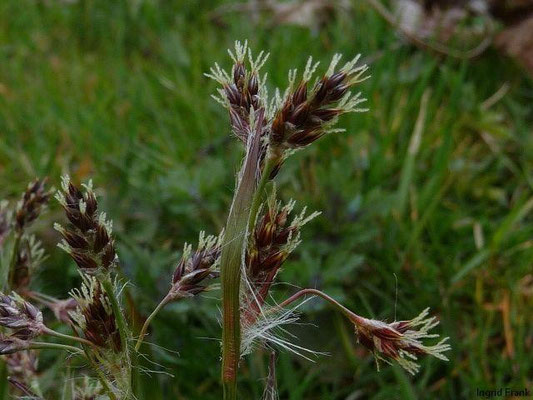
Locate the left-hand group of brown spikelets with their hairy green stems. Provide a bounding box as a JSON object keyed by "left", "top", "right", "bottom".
{"left": 0, "top": 177, "right": 131, "bottom": 398}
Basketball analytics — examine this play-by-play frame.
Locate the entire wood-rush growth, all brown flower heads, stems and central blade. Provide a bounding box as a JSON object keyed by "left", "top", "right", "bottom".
{"left": 0, "top": 42, "right": 450, "bottom": 400}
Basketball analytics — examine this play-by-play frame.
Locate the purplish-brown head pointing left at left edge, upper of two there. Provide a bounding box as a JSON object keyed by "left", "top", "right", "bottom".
{"left": 0, "top": 293, "right": 45, "bottom": 340}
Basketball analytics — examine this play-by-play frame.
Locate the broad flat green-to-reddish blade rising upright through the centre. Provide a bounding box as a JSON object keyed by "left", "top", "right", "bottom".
{"left": 220, "top": 126, "right": 263, "bottom": 400}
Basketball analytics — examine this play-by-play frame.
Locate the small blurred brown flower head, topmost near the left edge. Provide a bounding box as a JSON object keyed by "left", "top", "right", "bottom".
{"left": 15, "top": 179, "right": 50, "bottom": 232}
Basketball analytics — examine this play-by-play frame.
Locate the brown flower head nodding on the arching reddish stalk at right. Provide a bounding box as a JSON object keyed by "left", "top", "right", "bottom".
{"left": 352, "top": 308, "right": 451, "bottom": 375}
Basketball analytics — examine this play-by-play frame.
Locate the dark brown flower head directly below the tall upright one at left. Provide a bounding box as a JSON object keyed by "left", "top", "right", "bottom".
{"left": 70, "top": 273, "right": 122, "bottom": 353}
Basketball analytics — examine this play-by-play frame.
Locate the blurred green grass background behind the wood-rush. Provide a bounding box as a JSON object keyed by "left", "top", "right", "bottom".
{"left": 0, "top": 0, "right": 533, "bottom": 400}
